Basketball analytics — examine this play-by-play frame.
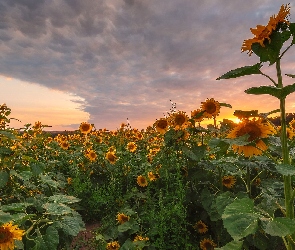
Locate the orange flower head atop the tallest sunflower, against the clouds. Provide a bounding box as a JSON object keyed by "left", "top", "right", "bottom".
{"left": 241, "top": 4, "right": 290, "bottom": 56}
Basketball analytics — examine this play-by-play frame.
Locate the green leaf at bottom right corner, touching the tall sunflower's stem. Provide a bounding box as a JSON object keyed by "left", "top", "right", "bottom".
{"left": 265, "top": 217, "right": 295, "bottom": 237}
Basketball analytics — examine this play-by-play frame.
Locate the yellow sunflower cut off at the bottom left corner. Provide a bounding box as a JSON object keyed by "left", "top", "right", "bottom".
{"left": 0, "top": 222, "right": 25, "bottom": 250}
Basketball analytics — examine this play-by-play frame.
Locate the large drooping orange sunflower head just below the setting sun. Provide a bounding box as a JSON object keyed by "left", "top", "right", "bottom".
{"left": 227, "top": 119, "right": 274, "bottom": 157}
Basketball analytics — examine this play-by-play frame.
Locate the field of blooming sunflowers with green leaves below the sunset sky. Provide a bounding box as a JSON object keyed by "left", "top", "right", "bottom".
{"left": 0, "top": 5, "right": 295, "bottom": 250}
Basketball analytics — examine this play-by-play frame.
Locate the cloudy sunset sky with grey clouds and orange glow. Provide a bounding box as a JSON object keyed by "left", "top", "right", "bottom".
{"left": 0, "top": 0, "right": 295, "bottom": 131}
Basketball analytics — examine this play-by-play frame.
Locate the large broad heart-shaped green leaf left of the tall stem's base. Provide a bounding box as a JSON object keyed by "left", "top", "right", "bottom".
{"left": 222, "top": 198, "right": 259, "bottom": 240}
